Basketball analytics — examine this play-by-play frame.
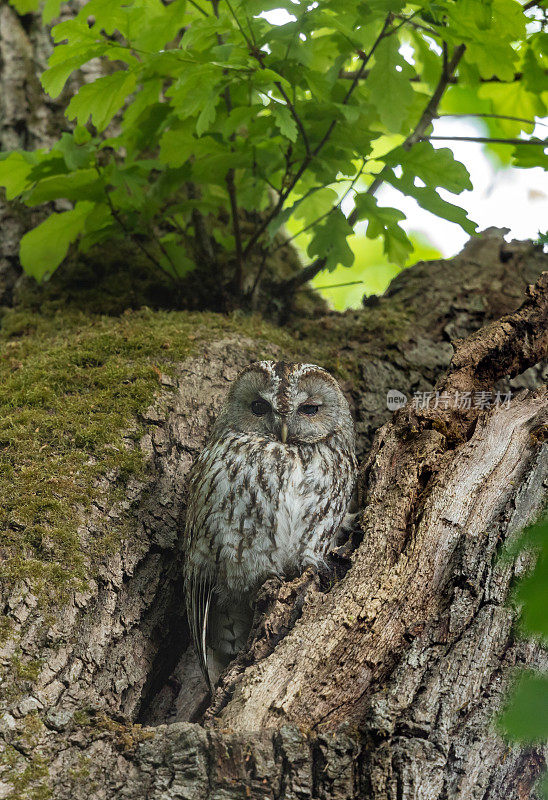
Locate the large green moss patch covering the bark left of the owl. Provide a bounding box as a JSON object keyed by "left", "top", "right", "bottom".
{"left": 0, "top": 309, "right": 295, "bottom": 602}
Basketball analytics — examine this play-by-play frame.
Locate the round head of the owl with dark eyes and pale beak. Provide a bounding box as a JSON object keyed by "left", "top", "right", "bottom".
{"left": 213, "top": 361, "right": 354, "bottom": 445}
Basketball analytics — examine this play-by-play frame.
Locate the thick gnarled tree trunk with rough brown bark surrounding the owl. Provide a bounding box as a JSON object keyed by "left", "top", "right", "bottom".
{"left": 0, "top": 6, "right": 548, "bottom": 800}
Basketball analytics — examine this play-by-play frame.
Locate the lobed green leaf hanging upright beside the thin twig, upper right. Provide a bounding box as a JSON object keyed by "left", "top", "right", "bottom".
{"left": 367, "top": 36, "right": 414, "bottom": 133}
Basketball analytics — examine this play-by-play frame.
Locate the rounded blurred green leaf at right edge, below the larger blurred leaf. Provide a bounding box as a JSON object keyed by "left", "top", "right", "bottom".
{"left": 500, "top": 672, "right": 548, "bottom": 743}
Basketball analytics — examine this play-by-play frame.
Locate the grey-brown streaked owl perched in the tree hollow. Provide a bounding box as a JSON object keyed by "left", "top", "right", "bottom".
{"left": 184, "top": 361, "right": 356, "bottom": 691}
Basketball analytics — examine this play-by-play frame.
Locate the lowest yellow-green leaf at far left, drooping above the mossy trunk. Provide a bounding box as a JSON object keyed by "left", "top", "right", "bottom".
{"left": 19, "top": 202, "right": 94, "bottom": 281}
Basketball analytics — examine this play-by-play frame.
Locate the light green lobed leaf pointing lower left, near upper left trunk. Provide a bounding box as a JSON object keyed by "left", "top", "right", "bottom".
{"left": 66, "top": 70, "right": 137, "bottom": 131}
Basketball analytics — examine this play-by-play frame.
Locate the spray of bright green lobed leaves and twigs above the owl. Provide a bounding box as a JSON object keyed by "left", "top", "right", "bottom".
{"left": 0, "top": 0, "right": 546, "bottom": 304}
